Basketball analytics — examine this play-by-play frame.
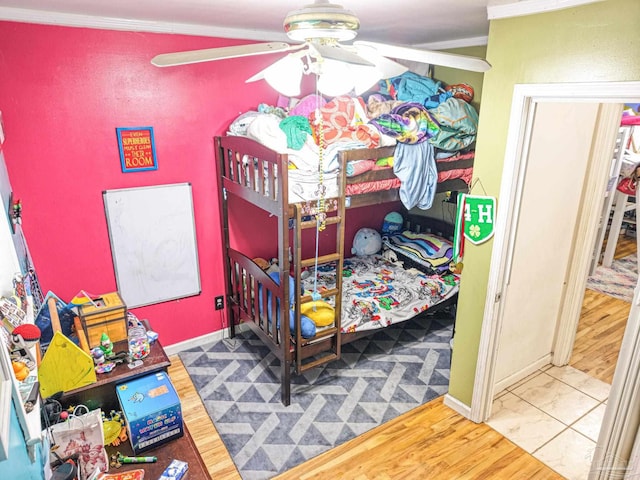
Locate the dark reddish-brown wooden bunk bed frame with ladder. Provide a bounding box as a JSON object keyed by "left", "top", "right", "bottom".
{"left": 215, "top": 136, "right": 468, "bottom": 405}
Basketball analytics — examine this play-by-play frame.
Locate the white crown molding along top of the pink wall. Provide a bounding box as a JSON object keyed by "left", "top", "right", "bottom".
{"left": 0, "top": 7, "right": 287, "bottom": 41}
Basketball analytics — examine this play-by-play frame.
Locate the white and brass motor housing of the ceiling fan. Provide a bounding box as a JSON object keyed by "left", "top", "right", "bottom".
{"left": 283, "top": 1, "right": 360, "bottom": 42}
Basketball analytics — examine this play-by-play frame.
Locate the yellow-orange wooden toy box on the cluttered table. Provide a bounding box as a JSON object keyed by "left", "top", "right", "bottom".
{"left": 78, "top": 292, "right": 127, "bottom": 348}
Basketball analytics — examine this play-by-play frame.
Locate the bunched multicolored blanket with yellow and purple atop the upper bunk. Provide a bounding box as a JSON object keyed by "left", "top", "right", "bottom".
{"left": 370, "top": 103, "right": 440, "bottom": 144}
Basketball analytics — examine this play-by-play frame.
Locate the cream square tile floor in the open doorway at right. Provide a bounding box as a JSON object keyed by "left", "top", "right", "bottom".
{"left": 487, "top": 365, "right": 611, "bottom": 480}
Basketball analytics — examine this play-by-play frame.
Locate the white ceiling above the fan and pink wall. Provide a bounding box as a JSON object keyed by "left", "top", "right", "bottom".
{"left": 0, "top": 0, "right": 496, "bottom": 47}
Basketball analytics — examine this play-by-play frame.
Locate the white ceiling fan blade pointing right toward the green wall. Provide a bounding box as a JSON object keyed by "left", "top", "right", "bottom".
{"left": 353, "top": 41, "right": 491, "bottom": 72}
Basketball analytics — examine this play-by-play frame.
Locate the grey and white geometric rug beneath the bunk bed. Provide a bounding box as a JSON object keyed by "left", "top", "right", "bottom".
{"left": 179, "top": 312, "right": 453, "bottom": 480}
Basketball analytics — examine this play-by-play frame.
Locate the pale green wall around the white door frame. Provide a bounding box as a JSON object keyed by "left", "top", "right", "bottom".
{"left": 449, "top": 0, "right": 640, "bottom": 405}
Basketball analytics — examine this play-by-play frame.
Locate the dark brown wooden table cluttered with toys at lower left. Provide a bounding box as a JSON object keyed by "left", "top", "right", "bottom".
{"left": 60, "top": 342, "right": 211, "bottom": 480}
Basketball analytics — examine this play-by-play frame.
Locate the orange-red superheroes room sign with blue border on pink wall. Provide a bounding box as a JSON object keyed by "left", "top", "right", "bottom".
{"left": 116, "top": 127, "right": 158, "bottom": 173}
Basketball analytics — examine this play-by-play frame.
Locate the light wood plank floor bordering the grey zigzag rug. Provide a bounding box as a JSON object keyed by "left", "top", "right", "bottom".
{"left": 169, "top": 356, "right": 562, "bottom": 480}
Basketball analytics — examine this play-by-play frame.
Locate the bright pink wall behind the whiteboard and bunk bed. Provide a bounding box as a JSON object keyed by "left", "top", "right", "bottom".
{"left": 0, "top": 22, "right": 390, "bottom": 345}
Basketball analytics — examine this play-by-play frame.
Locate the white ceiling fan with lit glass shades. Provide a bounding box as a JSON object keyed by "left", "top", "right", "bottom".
{"left": 151, "top": 0, "right": 491, "bottom": 96}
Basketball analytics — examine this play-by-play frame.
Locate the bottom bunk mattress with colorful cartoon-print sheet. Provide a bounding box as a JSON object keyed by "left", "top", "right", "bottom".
{"left": 303, "top": 255, "right": 460, "bottom": 333}
